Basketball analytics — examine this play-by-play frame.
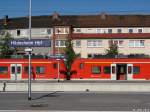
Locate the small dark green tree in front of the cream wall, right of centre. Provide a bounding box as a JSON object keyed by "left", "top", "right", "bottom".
{"left": 106, "top": 41, "right": 118, "bottom": 57}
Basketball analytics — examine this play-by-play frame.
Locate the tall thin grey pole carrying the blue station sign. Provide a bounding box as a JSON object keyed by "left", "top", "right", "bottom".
{"left": 26, "top": 0, "right": 32, "bottom": 100}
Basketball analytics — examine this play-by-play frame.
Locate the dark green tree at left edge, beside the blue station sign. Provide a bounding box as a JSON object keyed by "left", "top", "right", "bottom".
{"left": 0, "top": 31, "right": 16, "bottom": 58}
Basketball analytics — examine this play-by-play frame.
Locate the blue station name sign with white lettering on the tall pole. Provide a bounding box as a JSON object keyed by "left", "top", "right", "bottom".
{"left": 9, "top": 39, "right": 51, "bottom": 47}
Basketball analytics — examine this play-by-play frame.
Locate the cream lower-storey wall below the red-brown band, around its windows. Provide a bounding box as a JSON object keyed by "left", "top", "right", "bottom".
{"left": 73, "top": 39, "right": 150, "bottom": 58}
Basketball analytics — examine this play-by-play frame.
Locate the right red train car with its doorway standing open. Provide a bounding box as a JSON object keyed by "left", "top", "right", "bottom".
{"left": 71, "top": 58, "right": 150, "bottom": 80}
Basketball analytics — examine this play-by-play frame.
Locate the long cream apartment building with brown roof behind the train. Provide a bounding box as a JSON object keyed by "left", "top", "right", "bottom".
{"left": 0, "top": 12, "right": 150, "bottom": 58}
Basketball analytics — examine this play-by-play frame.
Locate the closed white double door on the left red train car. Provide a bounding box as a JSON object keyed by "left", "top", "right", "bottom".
{"left": 10, "top": 64, "right": 22, "bottom": 80}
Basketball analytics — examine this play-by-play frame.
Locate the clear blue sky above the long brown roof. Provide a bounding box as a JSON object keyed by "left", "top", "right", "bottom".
{"left": 0, "top": 0, "right": 150, "bottom": 18}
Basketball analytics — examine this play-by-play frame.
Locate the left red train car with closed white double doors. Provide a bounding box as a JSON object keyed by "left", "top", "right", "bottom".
{"left": 0, "top": 59, "right": 66, "bottom": 80}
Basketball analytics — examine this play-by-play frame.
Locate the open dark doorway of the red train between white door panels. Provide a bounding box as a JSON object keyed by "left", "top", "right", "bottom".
{"left": 116, "top": 64, "right": 127, "bottom": 80}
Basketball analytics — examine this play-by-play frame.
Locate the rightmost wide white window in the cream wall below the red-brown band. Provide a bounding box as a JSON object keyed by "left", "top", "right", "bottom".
{"left": 129, "top": 40, "right": 145, "bottom": 47}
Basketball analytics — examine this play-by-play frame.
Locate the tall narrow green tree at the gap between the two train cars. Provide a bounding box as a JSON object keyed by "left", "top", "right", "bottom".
{"left": 65, "top": 39, "right": 77, "bottom": 80}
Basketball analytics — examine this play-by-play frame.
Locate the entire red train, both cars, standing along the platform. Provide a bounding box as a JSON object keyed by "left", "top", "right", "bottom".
{"left": 0, "top": 59, "right": 150, "bottom": 80}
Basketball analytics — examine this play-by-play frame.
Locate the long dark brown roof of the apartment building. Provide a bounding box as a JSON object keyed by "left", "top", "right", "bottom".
{"left": 0, "top": 14, "right": 150, "bottom": 29}
